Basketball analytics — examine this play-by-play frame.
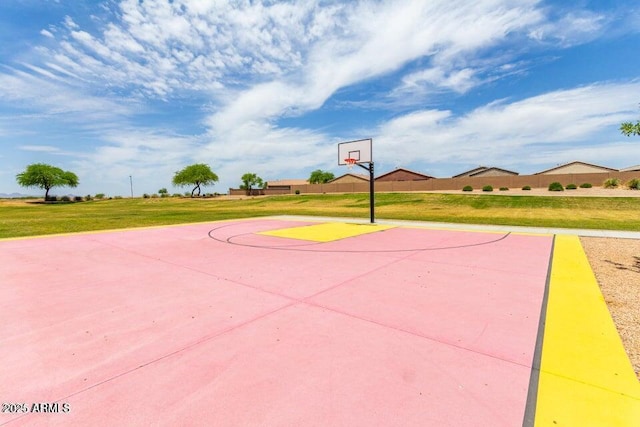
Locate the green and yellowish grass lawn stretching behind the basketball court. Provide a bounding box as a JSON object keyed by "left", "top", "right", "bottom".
{"left": 0, "top": 193, "right": 640, "bottom": 238}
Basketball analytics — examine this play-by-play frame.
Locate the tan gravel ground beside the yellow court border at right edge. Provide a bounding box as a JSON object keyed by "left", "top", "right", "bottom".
{"left": 580, "top": 237, "right": 640, "bottom": 380}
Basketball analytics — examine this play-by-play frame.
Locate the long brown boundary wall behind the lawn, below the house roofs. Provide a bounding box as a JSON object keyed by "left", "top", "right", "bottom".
{"left": 288, "top": 172, "right": 640, "bottom": 194}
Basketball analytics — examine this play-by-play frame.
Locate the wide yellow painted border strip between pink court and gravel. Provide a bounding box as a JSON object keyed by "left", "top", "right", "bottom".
{"left": 535, "top": 235, "right": 640, "bottom": 427}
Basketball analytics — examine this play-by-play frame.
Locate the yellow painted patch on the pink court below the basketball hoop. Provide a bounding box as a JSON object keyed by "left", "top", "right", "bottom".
{"left": 258, "top": 222, "right": 396, "bottom": 242}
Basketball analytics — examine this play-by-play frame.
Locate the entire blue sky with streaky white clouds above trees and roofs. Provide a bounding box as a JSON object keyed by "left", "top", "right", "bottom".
{"left": 0, "top": 0, "right": 640, "bottom": 196}
